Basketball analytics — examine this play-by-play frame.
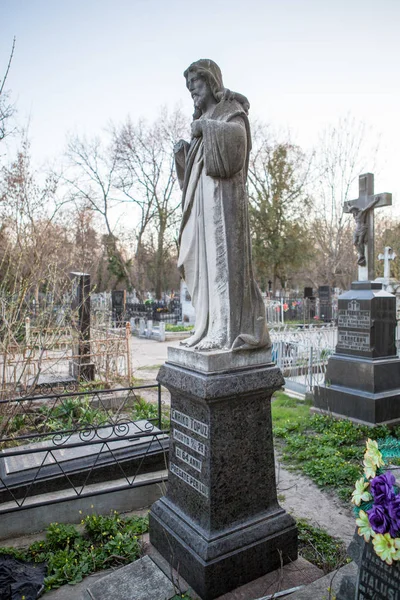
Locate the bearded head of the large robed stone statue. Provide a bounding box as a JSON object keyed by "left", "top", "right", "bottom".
{"left": 183, "top": 58, "right": 250, "bottom": 119}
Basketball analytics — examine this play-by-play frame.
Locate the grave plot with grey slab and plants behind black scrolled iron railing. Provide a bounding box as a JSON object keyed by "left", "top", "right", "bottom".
{"left": 0, "top": 386, "right": 168, "bottom": 510}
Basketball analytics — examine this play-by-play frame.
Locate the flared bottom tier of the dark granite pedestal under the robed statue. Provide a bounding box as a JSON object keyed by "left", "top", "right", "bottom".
{"left": 150, "top": 498, "right": 297, "bottom": 600}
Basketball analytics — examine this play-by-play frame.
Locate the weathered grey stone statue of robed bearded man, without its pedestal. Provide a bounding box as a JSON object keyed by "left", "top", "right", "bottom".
{"left": 174, "top": 59, "right": 271, "bottom": 350}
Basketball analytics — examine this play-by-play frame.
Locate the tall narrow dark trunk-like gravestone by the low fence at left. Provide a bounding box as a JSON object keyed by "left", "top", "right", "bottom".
{"left": 70, "top": 273, "right": 95, "bottom": 381}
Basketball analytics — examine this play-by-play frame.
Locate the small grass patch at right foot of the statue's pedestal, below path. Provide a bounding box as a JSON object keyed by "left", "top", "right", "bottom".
{"left": 297, "top": 519, "right": 350, "bottom": 574}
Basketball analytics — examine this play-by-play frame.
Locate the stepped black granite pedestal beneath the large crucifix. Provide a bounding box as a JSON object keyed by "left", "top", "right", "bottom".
{"left": 312, "top": 281, "right": 400, "bottom": 425}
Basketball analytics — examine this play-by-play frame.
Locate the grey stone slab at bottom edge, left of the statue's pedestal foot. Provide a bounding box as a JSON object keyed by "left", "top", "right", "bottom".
{"left": 81, "top": 556, "right": 175, "bottom": 600}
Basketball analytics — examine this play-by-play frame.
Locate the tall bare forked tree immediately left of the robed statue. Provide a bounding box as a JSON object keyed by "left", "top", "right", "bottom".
{"left": 114, "top": 109, "right": 186, "bottom": 298}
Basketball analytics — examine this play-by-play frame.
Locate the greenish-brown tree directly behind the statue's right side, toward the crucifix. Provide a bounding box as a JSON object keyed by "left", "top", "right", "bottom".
{"left": 248, "top": 125, "right": 312, "bottom": 291}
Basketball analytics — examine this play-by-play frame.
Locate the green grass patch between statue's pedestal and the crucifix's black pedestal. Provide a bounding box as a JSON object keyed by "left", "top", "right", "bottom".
{"left": 272, "top": 392, "right": 400, "bottom": 501}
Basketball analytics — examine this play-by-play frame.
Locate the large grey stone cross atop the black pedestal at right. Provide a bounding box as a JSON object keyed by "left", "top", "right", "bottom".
{"left": 343, "top": 173, "right": 392, "bottom": 281}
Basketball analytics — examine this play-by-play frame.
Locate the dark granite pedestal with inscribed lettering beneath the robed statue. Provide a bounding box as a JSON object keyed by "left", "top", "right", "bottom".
{"left": 150, "top": 348, "right": 297, "bottom": 600}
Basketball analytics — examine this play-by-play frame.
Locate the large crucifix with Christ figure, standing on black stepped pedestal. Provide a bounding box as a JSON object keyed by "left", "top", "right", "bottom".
{"left": 343, "top": 173, "right": 392, "bottom": 281}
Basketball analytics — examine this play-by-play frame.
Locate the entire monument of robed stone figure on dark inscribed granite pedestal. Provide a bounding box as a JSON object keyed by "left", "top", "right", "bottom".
{"left": 150, "top": 59, "right": 297, "bottom": 600}
